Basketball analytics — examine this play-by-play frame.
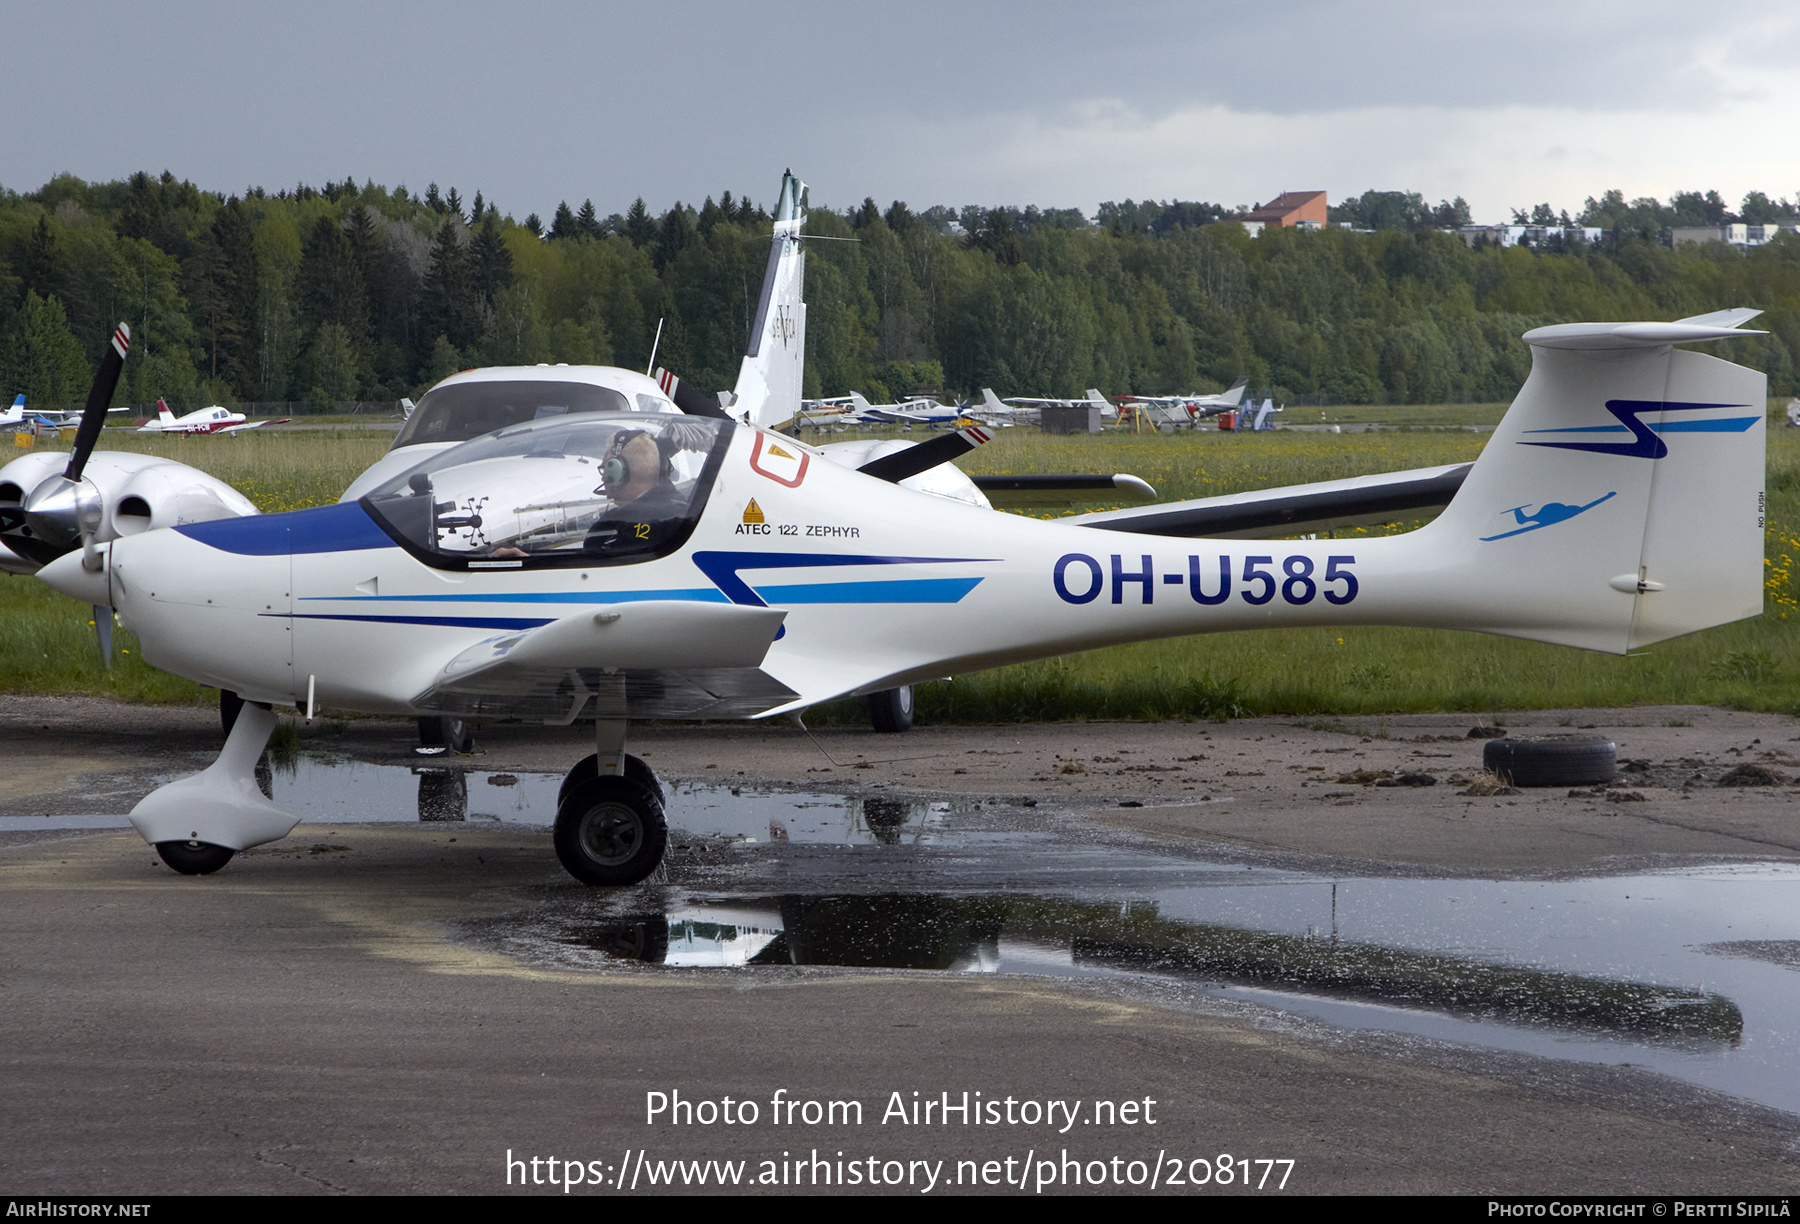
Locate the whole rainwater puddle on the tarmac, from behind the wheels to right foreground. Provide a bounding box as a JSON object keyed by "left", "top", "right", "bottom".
{"left": 14, "top": 756, "right": 1800, "bottom": 1112}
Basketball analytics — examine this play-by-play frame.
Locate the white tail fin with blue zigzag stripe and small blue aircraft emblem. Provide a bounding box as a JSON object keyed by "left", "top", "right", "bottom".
{"left": 1424, "top": 320, "right": 1768, "bottom": 653}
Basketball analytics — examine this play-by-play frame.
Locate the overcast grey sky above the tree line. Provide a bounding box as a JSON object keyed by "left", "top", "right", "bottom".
{"left": 0, "top": 0, "right": 1800, "bottom": 221}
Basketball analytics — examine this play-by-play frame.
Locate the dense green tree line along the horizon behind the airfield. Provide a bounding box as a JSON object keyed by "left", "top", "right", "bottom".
{"left": 0, "top": 173, "right": 1800, "bottom": 409}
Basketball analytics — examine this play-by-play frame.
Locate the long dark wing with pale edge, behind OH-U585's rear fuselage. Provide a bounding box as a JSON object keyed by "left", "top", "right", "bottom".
{"left": 1060, "top": 463, "right": 1474, "bottom": 540}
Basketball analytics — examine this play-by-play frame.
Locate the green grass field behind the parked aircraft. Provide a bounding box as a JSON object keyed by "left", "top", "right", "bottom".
{"left": 0, "top": 414, "right": 1800, "bottom": 724}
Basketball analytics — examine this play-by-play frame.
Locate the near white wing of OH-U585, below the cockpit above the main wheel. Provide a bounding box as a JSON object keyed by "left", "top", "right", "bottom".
{"left": 412, "top": 599, "right": 797, "bottom": 724}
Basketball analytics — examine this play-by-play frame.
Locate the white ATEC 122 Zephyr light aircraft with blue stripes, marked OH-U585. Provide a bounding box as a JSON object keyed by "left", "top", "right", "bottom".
{"left": 25, "top": 288, "right": 1766, "bottom": 884}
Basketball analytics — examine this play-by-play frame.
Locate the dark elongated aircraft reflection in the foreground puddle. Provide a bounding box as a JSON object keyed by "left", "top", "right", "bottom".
{"left": 547, "top": 893, "right": 1744, "bottom": 1048}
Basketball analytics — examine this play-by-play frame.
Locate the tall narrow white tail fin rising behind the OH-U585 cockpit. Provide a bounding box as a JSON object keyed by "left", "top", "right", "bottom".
{"left": 731, "top": 171, "right": 806, "bottom": 428}
